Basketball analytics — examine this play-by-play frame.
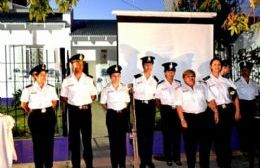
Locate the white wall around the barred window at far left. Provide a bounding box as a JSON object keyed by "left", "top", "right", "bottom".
{"left": 0, "top": 23, "right": 71, "bottom": 98}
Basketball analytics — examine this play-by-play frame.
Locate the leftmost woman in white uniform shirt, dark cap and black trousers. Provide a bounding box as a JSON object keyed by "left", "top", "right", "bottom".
{"left": 21, "top": 64, "right": 58, "bottom": 168}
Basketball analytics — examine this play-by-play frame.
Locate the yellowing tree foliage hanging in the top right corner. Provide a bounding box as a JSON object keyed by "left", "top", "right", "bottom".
{"left": 173, "top": 0, "right": 260, "bottom": 36}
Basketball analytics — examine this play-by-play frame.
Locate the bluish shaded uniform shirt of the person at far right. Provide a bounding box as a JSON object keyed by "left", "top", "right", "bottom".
{"left": 235, "top": 77, "right": 260, "bottom": 100}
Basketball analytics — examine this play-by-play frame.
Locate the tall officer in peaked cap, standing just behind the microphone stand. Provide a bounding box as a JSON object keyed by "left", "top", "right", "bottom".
{"left": 133, "top": 56, "right": 158, "bottom": 168}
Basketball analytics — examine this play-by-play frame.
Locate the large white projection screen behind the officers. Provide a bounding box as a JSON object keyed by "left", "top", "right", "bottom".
{"left": 113, "top": 11, "right": 216, "bottom": 84}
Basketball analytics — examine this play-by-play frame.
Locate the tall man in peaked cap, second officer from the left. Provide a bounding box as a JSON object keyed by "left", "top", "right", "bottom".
{"left": 61, "top": 54, "right": 97, "bottom": 168}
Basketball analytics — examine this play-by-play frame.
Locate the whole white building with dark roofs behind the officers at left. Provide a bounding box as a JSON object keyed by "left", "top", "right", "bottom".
{"left": 0, "top": 4, "right": 117, "bottom": 101}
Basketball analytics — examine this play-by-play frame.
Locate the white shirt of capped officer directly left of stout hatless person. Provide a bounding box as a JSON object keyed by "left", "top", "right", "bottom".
{"left": 155, "top": 79, "right": 180, "bottom": 106}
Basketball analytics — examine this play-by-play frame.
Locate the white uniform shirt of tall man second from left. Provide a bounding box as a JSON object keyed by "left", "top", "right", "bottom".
{"left": 61, "top": 73, "right": 97, "bottom": 106}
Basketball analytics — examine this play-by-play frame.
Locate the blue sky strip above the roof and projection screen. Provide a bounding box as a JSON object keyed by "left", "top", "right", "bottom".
{"left": 51, "top": 0, "right": 163, "bottom": 19}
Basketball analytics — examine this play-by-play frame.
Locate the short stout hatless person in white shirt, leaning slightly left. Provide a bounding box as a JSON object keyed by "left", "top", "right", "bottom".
{"left": 175, "top": 70, "right": 218, "bottom": 168}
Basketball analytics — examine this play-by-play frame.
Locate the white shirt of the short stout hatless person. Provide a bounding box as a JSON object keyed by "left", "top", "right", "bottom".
{"left": 175, "top": 83, "right": 214, "bottom": 114}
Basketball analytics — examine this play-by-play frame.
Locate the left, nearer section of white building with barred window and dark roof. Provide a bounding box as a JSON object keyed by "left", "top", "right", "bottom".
{"left": 0, "top": 9, "right": 71, "bottom": 98}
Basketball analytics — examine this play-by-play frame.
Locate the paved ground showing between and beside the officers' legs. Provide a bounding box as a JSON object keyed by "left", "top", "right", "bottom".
{"left": 13, "top": 102, "right": 257, "bottom": 168}
